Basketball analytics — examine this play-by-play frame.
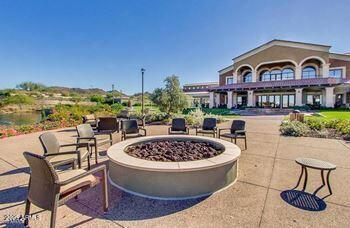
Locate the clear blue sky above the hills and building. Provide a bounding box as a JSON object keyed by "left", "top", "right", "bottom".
{"left": 0, "top": 0, "right": 350, "bottom": 94}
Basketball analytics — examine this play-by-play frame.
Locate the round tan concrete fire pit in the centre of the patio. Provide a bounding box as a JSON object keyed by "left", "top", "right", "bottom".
{"left": 107, "top": 135, "right": 241, "bottom": 199}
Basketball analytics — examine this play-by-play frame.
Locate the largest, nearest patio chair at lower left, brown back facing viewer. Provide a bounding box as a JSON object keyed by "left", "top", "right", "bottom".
{"left": 23, "top": 152, "right": 108, "bottom": 228}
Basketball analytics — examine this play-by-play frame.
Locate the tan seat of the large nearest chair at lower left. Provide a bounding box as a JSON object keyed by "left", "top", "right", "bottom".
{"left": 57, "top": 169, "right": 99, "bottom": 195}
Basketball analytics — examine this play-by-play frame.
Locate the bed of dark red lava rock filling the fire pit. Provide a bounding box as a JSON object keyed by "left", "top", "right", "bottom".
{"left": 125, "top": 140, "right": 223, "bottom": 162}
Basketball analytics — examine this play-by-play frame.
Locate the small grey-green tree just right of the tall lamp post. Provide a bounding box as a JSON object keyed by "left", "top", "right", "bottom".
{"left": 150, "top": 75, "right": 189, "bottom": 115}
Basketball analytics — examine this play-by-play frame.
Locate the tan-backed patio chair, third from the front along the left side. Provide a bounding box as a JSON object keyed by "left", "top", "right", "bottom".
{"left": 76, "top": 124, "right": 113, "bottom": 164}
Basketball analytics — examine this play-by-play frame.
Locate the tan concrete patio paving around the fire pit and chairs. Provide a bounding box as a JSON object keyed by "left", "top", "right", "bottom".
{"left": 0, "top": 116, "right": 350, "bottom": 227}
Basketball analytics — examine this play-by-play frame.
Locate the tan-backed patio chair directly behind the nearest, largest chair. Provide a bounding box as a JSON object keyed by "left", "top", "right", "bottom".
{"left": 39, "top": 132, "right": 90, "bottom": 169}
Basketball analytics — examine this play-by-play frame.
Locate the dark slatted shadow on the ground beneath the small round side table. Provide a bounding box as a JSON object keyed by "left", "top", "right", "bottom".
{"left": 280, "top": 190, "right": 327, "bottom": 211}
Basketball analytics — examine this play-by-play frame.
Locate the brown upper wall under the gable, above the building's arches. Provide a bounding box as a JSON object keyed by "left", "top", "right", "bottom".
{"left": 234, "top": 46, "right": 329, "bottom": 69}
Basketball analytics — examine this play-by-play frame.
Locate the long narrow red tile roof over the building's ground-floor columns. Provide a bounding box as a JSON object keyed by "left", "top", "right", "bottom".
{"left": 210, "top": 78, "right": 349, "bottom": 91}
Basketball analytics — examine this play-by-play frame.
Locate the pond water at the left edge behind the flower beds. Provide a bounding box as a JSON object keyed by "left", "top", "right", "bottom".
{"left": 0, "top": 112, "right": 42, "bottom": 126}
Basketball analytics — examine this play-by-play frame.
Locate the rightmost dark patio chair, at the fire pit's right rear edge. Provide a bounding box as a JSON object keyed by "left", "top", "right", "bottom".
{"left": 219, "top": 120, "right": 247, "bottom": 149}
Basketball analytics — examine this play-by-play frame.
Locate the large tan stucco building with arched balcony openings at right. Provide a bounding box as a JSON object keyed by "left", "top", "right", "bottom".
{"left": 209, "top": 40, "right": 350, "bottom": 108}
